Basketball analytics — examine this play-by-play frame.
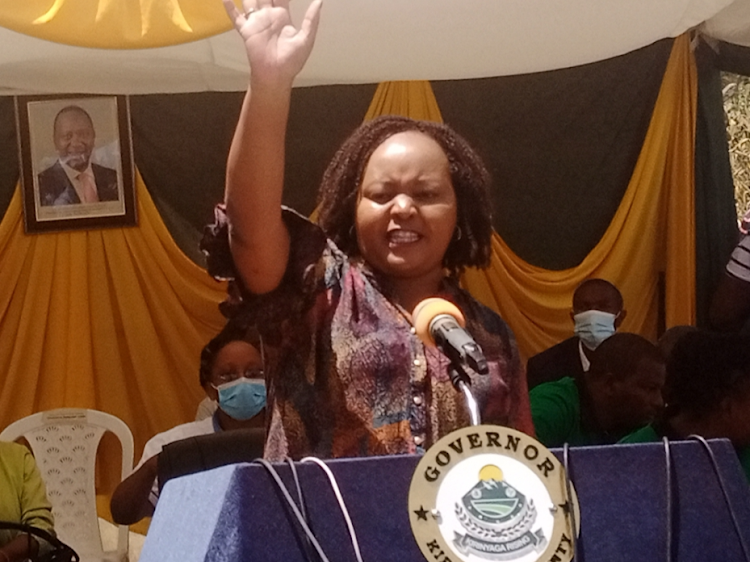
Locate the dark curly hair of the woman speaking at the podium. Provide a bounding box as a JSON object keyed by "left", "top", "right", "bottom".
{"left": 318, "top": 115, "right": 492, "bottom": 275}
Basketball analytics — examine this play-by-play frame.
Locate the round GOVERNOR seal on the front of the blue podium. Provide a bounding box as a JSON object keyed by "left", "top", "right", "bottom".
{"left": 409, "top": 425, "right": 577, "bottom": 562}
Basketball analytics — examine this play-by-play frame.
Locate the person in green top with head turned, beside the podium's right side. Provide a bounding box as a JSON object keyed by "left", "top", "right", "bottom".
{"left": 530, "top": 332, "right": 665, "bottom": 447}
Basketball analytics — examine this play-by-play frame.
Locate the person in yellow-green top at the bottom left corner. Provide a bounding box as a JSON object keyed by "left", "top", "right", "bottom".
{"left": 0, "top": 441, "right": 55, "bottom": 562}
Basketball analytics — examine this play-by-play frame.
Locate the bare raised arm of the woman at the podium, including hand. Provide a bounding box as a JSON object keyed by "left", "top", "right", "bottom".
{"left": 223, "top": 0, "right": 321, "bottom": 293}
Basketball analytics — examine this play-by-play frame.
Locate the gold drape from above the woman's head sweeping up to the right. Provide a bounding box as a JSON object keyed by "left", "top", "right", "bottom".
{"left": 365, "top": 35, "right": 697, "bottom": 357}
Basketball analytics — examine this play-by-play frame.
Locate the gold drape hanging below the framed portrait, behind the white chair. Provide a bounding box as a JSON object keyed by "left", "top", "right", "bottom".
{"left": 0, "top": 168, "right": 226, "bottom": 480}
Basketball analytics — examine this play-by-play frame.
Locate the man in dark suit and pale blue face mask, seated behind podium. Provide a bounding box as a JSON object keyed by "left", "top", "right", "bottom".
{"left": 526, "top": 279, "right": 626, "bottom": 390}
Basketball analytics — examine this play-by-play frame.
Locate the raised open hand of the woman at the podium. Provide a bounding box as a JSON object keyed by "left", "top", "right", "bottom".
{"left": 223, "top": 0, "right": 322, "bottom": 87}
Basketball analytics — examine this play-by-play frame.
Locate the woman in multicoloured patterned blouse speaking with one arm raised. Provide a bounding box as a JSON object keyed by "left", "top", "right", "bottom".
{"left": 203, "top": 0, "right": 532, "bottom": 460}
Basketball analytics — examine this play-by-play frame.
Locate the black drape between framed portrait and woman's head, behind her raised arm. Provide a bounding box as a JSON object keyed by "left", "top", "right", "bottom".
{"left": 130, "top": 85, "right": 375, "bottom": 264}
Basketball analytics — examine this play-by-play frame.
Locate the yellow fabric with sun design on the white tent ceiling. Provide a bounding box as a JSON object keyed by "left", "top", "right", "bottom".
{"left": 0, "top": 0, "right": 241, "bottom": 49}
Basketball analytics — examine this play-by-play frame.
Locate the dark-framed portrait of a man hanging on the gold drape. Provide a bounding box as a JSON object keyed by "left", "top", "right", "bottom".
{"left": 16, "top": 95, "right": 137, "bottom": 233}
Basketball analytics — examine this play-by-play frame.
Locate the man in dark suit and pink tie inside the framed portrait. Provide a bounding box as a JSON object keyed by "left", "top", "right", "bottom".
{"left": 38, "top": 105, "right": 119, "bottom": 206}
